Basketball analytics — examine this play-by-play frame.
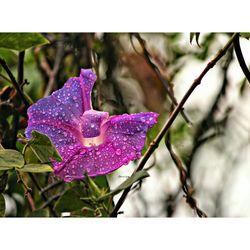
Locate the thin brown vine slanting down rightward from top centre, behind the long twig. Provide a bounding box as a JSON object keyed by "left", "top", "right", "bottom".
{"left": 130, "top": 33, "right": 192, "bottom": 125}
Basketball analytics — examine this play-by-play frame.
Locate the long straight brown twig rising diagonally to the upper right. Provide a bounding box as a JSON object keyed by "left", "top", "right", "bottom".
{"left": 111, "top": 33, "right": 237, "bottom": 217}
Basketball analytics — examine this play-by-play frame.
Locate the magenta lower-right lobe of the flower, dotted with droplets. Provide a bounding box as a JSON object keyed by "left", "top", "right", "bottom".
{"left": 55, "top": 112, "right": 158, "bottom": 181}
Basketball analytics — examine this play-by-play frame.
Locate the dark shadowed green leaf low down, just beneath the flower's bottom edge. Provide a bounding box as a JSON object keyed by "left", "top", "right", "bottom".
{"left": 55, "top": 186, "right": 86, "bottom": 213}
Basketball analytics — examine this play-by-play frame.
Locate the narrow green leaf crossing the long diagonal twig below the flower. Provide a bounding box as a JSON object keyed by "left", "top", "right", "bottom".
{"left": 98, "top": 170, "right": 149, "bottom": 201}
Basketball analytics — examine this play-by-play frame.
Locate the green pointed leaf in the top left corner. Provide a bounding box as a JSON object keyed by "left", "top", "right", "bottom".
{"left": 0, "top": 33, "right": 49, "bottom": 51}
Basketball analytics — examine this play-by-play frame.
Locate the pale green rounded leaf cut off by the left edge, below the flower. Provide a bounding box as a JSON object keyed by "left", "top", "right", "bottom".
{"left": 0, "top": 149, "right": 24, "bottom": 170}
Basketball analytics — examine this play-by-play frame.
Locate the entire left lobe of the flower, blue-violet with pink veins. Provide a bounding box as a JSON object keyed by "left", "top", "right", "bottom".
{"left": 25, "top": 69, "right": 96, "bottom": 160}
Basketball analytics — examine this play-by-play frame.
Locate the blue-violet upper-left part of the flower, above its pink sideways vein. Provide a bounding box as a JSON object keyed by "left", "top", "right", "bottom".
{"left": 28, "top": 69, "right": 96, "bottom": 132}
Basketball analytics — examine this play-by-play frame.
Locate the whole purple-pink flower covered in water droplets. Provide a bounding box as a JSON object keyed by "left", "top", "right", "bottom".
{"left": 25, "top": 69, "right": 158, "bottom": 182}
